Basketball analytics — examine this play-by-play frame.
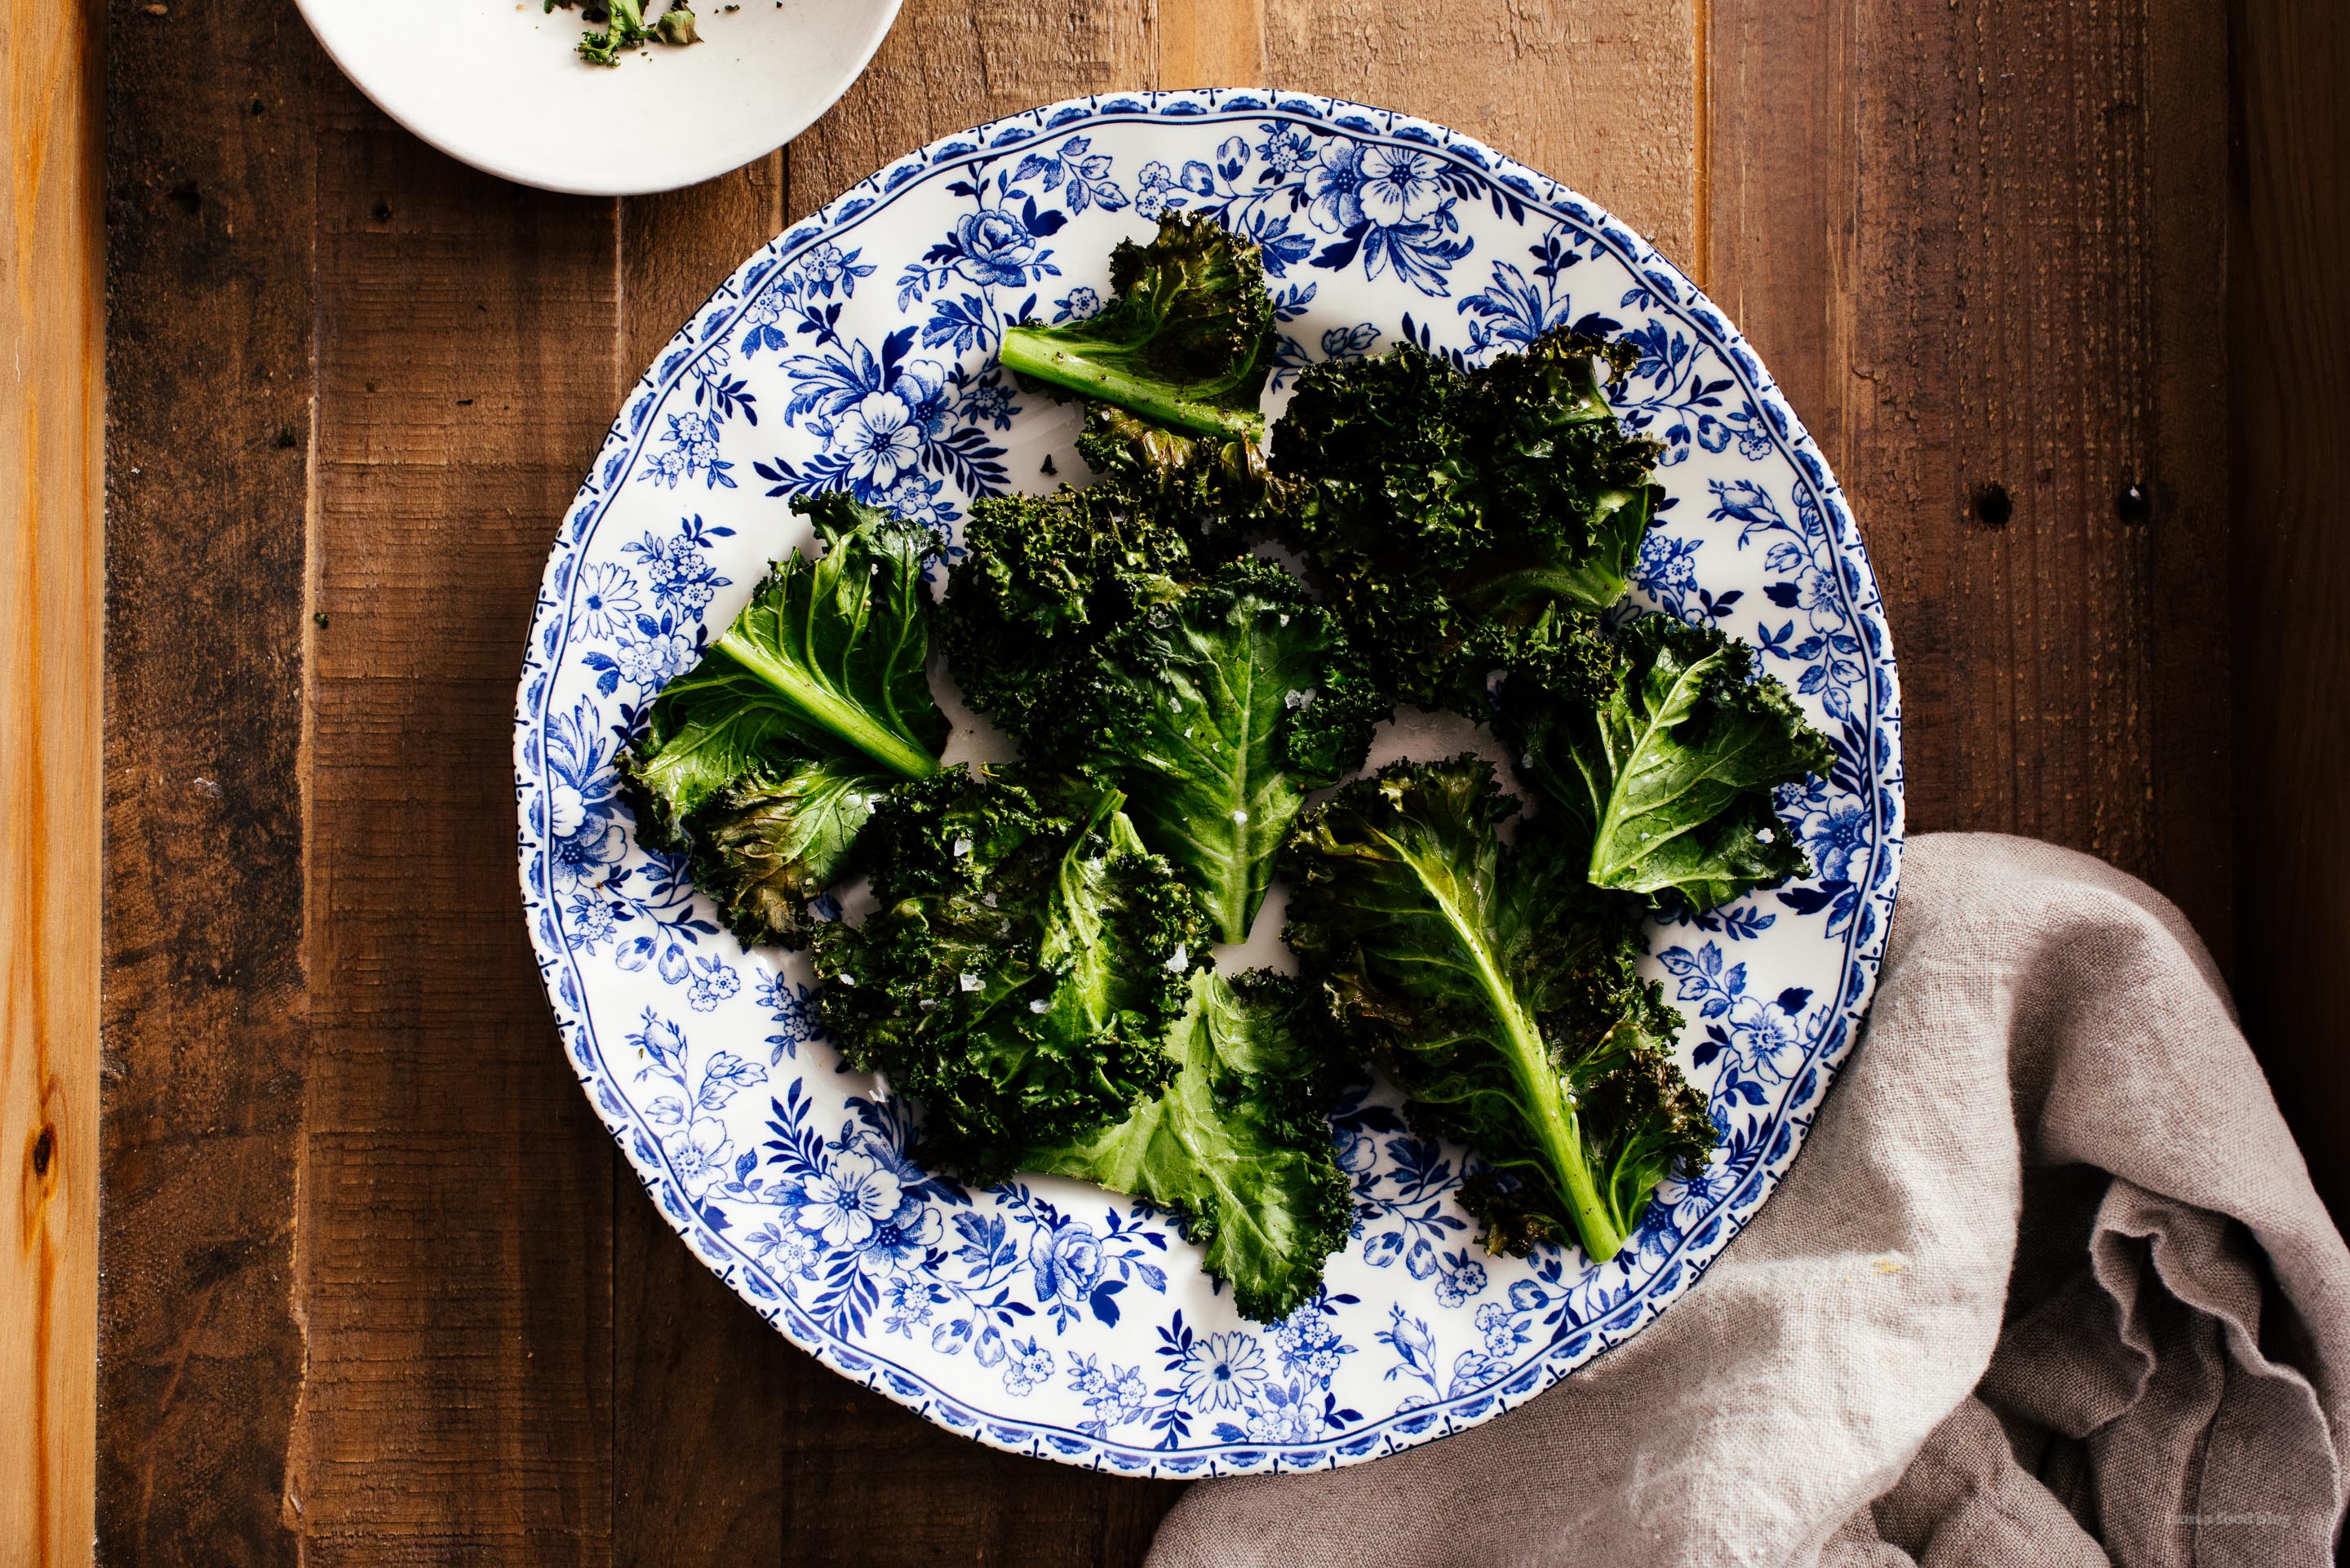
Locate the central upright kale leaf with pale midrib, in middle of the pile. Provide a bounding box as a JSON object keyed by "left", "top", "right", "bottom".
{"left": 1022, "top": 557, "right": 1389, "bottom": 943}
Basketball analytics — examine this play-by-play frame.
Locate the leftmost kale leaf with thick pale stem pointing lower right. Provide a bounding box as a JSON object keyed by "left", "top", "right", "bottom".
{"left": 620, "top": 494, "right": 947, "bottom": 947}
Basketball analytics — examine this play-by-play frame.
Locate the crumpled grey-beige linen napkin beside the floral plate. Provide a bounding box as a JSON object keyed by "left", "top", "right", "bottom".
{"left": 1149, "top": 835, "right": 2350, "bottom": 1568}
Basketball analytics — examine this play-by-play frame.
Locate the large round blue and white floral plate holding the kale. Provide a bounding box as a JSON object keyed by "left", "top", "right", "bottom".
{"left": 515, "top": 91, "right": 1901, "bottom": 1477}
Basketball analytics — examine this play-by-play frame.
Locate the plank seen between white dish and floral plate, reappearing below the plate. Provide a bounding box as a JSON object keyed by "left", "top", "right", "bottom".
{"left": 611, "top": 153, "right": 799, "bottom": 1568}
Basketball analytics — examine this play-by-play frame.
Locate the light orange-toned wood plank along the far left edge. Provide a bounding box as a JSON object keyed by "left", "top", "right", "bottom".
{"left": 0, "top": 0, "right": 106, "bottom": 1568}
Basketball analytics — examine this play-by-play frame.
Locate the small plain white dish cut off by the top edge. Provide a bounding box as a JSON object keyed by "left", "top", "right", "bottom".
{"left": 299, "top": 0, "right": 900, "bottom": 195}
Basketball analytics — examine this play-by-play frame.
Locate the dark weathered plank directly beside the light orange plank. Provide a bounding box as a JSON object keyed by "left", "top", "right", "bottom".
{"left": 96, "top": 7, "right": 317, "bottom": 1566}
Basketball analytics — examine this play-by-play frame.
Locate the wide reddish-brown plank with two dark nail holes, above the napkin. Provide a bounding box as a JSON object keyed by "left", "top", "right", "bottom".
{"left": 1706, "top": 0, "right": 2230, "bottom": 959}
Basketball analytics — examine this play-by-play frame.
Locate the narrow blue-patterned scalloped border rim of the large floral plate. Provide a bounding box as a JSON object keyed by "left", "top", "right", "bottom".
{"left": 515, "top": 89, "right": 1904, "bottom": 1479}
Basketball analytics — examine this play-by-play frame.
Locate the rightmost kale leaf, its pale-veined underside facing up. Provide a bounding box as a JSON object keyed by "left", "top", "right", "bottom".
{"left": 1499, "top": 616, "right": 1833, "bottom": 910}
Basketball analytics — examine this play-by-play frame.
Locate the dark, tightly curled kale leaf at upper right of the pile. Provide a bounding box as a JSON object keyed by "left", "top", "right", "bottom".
{"left": 1271, "top": 331, "right": 1659, "bottom": 720}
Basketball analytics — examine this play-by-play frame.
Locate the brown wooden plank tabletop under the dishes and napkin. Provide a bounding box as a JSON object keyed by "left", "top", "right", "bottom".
{"left": 0, "top": 0, "right": 2350, "bottom": 1568}
